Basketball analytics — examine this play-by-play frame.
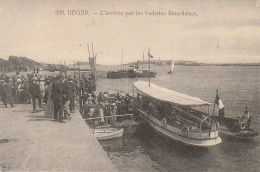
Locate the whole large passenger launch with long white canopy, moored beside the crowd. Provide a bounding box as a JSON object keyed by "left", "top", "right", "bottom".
{"left": 133, "top": 81, "right": 221, "bottom": 146}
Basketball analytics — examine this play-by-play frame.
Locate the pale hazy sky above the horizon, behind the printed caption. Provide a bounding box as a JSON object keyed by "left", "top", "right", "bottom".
{"left": 0, "top": 0, "right": 260, "bottom": 64}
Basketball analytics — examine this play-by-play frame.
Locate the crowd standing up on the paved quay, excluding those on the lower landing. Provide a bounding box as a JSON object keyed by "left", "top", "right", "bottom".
{"left": 0, "top": 74, "right": 79, "bottom": 122}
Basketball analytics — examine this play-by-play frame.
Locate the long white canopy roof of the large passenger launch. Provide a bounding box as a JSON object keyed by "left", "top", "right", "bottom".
{"left": 133, "top": 80, "right": 211, "bottom": 106}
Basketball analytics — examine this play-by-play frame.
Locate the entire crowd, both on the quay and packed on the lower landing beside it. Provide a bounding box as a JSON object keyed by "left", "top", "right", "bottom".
{"left": 0, "top": 73, "right": 137, "bottom": 123}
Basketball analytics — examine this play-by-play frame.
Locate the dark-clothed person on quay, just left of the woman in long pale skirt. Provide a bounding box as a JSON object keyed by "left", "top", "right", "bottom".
{"left": 30, "top": 78, "right": 41, "bottom": 111}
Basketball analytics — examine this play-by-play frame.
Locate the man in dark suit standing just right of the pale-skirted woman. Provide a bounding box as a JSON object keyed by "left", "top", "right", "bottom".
{"left": 52, "top": 75, "right": 64, "bottom": 123}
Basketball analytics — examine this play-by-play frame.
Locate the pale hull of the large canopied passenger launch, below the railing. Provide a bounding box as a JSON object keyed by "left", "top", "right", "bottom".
{"left": 139, "top": 110, "right": 222, "bottom": 147}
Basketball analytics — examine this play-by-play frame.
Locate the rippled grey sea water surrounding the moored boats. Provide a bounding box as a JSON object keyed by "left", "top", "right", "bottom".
{"left": 97, "top": 66, "right": 260, "bottom": 171}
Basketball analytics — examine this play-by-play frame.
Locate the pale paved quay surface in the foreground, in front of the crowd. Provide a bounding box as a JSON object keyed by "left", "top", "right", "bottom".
{"left": 0, "top": 104, "right": 116, "bottom": 171}
